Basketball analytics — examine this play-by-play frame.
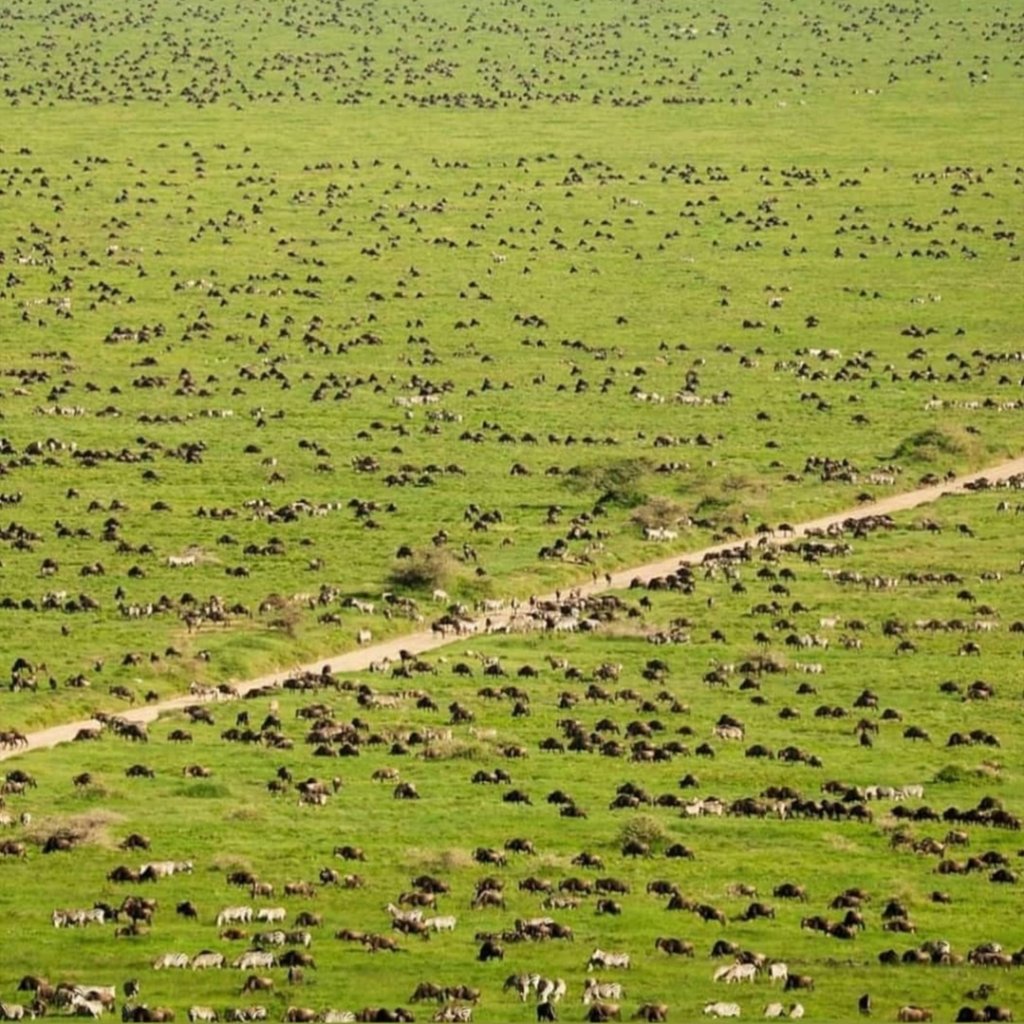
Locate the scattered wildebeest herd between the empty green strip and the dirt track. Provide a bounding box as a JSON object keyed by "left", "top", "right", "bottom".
{"left": 0, "top": 132, "right": 1024, "bottom": 699}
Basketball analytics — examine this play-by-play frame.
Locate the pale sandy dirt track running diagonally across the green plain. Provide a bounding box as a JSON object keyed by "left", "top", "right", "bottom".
{"left": 0, "top": 457, "right": 1024, "bottom": 761}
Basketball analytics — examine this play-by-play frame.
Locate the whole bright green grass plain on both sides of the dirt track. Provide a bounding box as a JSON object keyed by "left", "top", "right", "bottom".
{"left": 0, "top": 0, "right": 1024, "bottom": 1021}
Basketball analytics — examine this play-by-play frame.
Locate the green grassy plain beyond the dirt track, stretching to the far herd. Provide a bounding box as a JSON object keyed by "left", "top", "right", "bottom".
{"left": 0, "top": 3, "right": 1024, "bottom": 726}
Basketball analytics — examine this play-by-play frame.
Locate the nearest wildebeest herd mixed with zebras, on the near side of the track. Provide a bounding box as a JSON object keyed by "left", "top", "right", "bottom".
{"left": 0, "top": 474, "right": 1024, "bottom": 1022}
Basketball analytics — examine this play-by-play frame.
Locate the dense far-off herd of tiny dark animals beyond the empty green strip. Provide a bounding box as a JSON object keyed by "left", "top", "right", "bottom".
{"left": 0, "top": 0, "right": 1020, "bottom": 108}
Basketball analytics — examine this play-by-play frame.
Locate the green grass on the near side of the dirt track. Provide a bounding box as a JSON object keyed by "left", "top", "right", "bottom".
{"left": 0, "top": 495, "right": 1024, "bottom": 1021}
